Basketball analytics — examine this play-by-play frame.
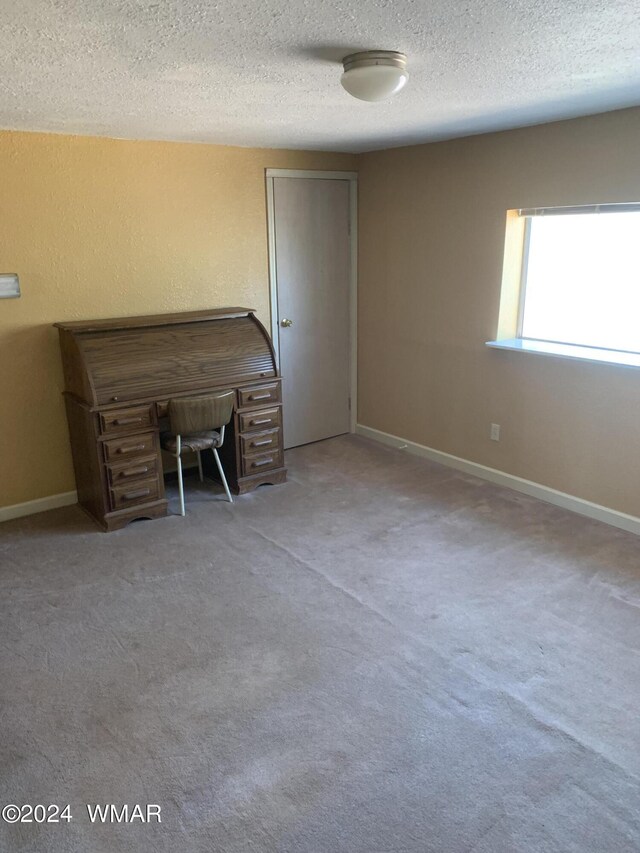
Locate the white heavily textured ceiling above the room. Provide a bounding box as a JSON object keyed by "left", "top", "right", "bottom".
{"left": 0, "top": 0, "right": 640, "bottom": 151}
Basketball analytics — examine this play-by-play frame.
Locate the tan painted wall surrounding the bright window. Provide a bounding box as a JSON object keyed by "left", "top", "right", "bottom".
{"left": 358, "top": 109, "right": 640, "bottom": 516}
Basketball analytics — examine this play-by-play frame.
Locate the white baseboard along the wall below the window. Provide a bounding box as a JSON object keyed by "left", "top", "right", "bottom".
{"left": 356, "top": 424, "right": 640, "bottom": 536}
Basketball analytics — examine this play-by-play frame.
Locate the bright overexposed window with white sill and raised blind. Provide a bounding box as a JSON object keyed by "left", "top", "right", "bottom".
{"left": 490, "top": 204, "right": 640, "bottom": 365}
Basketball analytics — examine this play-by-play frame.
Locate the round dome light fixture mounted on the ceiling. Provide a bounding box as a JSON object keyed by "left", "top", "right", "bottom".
{"left": 340, "top": 50, "right": 409, "bottom": 101}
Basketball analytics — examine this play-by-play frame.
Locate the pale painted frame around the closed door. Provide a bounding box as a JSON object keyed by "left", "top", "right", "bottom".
{"left": 265, "top": 169, "right": 358, "bottom": 432}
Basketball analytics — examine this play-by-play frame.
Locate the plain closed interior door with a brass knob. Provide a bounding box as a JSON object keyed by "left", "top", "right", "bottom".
{"left": 271, "top": 177, "right": 351, "bottom": 447}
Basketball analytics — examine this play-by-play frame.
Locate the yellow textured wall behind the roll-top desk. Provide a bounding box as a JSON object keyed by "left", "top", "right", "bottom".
{"left": 0, "top": 132, "right": 355, "bottom": 506}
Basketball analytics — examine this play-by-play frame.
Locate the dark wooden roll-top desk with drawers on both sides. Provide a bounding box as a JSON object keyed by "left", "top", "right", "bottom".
{"left": 55, "top": 308, "right": 287, "bottom": 530}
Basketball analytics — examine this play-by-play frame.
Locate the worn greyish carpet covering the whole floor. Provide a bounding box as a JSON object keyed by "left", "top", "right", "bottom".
{"left": 0, "top": 436, "right": 640, "bottom": 853}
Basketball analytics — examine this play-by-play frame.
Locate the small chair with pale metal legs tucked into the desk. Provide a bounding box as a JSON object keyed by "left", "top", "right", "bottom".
{"left": 161, "top": 391, "right": 235, "bottom": 515}
